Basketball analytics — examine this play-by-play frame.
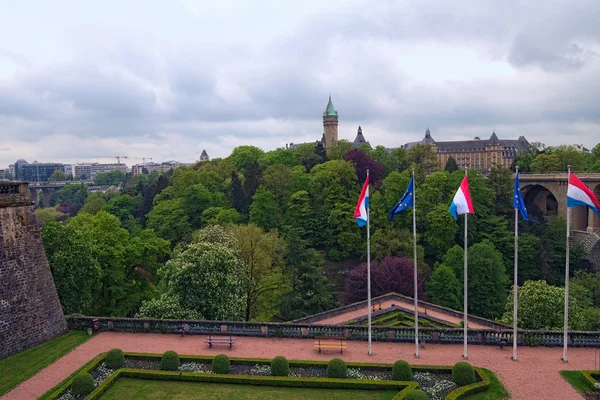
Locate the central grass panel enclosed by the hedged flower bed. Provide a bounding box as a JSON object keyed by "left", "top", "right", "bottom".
{"left": 101, "top": 378, "right": 398, "bottom": 400}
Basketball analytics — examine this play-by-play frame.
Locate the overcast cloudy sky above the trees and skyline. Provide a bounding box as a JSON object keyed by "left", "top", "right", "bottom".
{"left": 0, "top": 0, "right": 600, "bottom": 169}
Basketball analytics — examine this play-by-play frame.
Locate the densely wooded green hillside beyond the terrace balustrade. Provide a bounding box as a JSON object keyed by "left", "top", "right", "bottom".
{"left": 37, "top": 141, "right": 600, "bottom": 329}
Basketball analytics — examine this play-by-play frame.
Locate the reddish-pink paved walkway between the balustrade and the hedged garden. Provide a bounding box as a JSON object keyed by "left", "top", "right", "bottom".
{"left": 2, "top": 332, "right": 595, "bottom": 400}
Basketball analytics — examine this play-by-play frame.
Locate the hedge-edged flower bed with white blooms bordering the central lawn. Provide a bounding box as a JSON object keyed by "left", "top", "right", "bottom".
{"left": 42, "top": 353, "right": 489, "bottom": 400}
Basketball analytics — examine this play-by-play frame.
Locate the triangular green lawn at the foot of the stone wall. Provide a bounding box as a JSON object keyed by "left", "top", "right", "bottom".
{"left": 0, "top": 332, "right": 88, "bottom": 396}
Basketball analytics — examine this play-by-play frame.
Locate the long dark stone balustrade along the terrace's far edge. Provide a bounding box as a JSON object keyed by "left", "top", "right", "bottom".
{"left": 67, "top": 316, "right": 600, "bottom": 347}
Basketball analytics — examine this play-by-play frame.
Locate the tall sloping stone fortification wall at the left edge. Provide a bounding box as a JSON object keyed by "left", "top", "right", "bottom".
{"left": 0, "top": 182, "right": 67, "bottom": 360}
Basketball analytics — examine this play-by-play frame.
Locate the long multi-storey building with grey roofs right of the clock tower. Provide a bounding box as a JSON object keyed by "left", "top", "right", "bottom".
{"left": 404, "top": 128, "right": 529, "bottom": 173}
